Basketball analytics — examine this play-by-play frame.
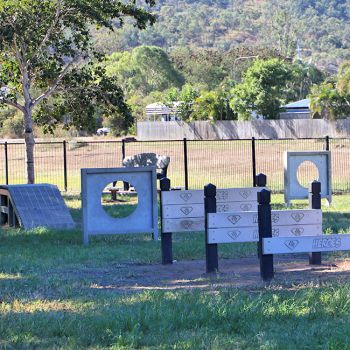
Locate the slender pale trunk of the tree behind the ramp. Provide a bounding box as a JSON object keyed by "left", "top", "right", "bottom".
{"left": 24, "top": 107, "right": 35, "bottom": 184}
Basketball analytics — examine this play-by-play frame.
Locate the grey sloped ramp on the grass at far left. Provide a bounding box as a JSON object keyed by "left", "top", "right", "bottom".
{"left": 0, "top": 184, "right": 75, "bottom": 229}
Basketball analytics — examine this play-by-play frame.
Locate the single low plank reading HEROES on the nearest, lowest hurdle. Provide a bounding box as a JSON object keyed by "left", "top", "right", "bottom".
{"left": 263, "top": 234, "right": 350, "bottom": 254}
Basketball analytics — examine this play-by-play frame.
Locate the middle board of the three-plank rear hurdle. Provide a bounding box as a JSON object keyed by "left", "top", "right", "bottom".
{"left": 162, "top": 202, "right": 257, "bottom": 219}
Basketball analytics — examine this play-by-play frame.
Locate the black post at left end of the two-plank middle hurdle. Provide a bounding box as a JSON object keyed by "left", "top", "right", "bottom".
{"left": 204, "top": 184, "right": 218, "bottom": 272}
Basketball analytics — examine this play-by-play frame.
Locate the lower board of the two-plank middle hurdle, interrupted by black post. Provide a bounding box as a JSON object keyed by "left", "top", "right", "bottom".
{"left": 208, "top": 224, "right": 322, "bottom": 244}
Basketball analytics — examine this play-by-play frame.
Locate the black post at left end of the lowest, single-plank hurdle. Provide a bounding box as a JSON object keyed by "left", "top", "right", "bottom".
{"left": 258, "top": 190, "right": 274, "bottom": 281}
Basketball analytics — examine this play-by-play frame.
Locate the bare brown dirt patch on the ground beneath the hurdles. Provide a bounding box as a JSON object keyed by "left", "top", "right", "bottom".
{"left": 80, "top": 257, "right": 350, "bottom": 293}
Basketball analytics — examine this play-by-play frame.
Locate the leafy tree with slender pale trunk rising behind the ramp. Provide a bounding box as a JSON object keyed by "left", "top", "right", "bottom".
{"left": 0, "top": 0, "right": 155, "bottom": 183}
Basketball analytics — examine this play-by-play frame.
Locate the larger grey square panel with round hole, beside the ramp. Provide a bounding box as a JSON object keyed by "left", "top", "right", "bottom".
{"left": 81, "top": 167, "right": 158, "bottom": 244}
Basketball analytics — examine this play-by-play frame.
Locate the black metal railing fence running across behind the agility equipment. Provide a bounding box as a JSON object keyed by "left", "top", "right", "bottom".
{"left": 0, "top": 137, "right": 350, "bottom": 192}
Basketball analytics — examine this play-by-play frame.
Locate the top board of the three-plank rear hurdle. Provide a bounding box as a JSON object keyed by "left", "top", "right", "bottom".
{"left": 161, "top": 187, "right": 265, "bottom": 205}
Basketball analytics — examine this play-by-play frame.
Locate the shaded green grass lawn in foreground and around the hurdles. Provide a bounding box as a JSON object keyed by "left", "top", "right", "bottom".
{"left": 0, "top": 195, "right": 350, "bottom": 349}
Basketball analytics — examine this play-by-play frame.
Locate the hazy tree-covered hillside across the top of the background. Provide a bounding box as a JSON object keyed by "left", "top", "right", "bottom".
{"left": 96, "top": 0, "right": 350, "bottom": 71}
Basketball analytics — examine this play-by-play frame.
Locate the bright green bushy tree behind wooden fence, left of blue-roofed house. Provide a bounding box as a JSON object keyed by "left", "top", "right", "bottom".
{"left": 230, "top": 58, "right": 292, "bottom": 120}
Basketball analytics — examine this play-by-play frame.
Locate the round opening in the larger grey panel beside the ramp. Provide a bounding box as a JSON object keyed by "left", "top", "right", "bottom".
{"left": 101, "top": 181, "right": 138, "bottom": 218}
